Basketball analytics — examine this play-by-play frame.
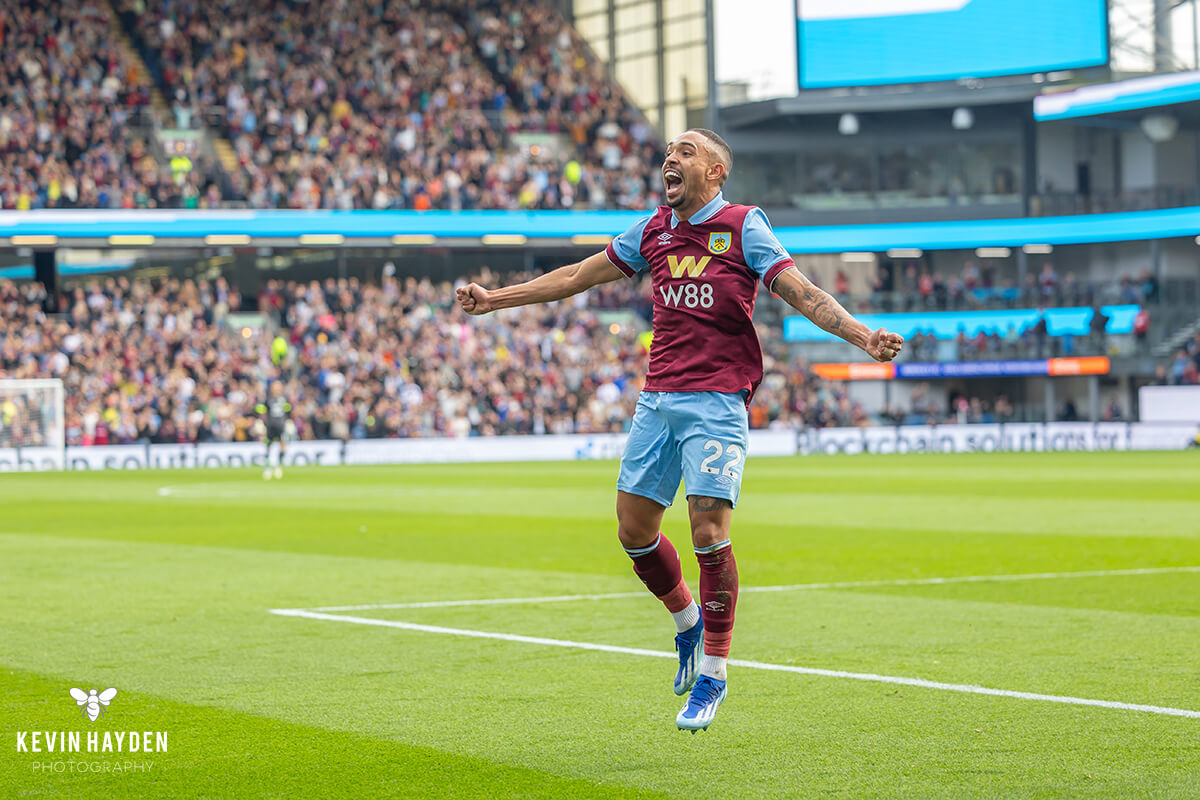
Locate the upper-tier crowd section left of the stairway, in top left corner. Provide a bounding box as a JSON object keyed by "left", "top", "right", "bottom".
{"left": 0, "top": 0, "right": 219, "bottom": 210}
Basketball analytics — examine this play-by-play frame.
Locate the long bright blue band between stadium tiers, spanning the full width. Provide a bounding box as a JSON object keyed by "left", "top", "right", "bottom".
{"left": 0, "top": 206, "right": 1200, "bottom": 253}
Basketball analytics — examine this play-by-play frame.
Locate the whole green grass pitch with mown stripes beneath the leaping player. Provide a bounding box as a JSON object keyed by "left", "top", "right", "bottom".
{"left": 0, "top": 452, "right": 1200, "bottom": 800}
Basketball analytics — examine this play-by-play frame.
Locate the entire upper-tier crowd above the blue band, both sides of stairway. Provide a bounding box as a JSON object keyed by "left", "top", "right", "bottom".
{"left": 0, "top": 0, "right": 661, "bottom": 209}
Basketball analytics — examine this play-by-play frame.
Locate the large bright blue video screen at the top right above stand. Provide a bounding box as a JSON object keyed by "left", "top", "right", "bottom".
{"left": 796, "top": 0, "right": 1109, "bottom": 89}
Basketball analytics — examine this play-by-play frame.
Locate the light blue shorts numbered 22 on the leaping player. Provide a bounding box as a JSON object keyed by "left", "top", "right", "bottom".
{"left": 617, "top": 392, "right": 750, "bottom": 506}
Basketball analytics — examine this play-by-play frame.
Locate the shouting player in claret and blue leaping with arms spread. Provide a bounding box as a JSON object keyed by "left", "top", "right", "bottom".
{"left": 457, "top": 128, "right": 904, "bottom": 732}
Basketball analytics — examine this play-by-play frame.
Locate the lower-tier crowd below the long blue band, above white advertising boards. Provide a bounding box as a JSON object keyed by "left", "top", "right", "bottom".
{"left": 0, "top": 272, "right": 902, "bottom": 445}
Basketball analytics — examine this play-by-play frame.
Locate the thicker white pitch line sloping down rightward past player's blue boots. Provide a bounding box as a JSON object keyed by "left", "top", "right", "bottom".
{"left": 270, "top": 608, "right": 1200, "bottom": 720}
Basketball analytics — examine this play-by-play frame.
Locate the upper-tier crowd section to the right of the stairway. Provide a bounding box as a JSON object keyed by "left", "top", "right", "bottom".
{"left": 119, "top": 0, "right": 656, "bottom": 210}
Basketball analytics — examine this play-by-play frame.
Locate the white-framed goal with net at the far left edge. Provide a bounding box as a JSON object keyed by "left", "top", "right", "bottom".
{"left": 0, "top": 379, "right": 66, "bottom": 471}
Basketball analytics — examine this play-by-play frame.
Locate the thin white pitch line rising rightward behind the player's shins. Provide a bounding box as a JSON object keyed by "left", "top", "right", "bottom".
{"left": 302, "top": 566, "right": 1200, "bottom": 612}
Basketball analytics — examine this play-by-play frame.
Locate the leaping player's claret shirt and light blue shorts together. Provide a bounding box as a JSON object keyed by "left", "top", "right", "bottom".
{"left": 606, "top": 194, "right": 793, "bottom": 505}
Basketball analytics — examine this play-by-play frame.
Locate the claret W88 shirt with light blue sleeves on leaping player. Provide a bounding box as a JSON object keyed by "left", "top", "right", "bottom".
{"left": 606, "top": 193, "right": 793, "bottom": 399}
